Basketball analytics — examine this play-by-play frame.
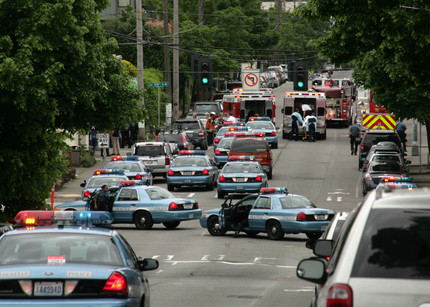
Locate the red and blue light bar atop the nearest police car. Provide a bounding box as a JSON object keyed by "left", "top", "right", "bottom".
{"left": 15, "top": 210, "right": 113, "bottom": 226}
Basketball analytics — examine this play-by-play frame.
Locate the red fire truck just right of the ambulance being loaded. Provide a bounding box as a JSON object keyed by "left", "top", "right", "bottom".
{"left": 312, "top": 79, "right": 356, "bottom": 127}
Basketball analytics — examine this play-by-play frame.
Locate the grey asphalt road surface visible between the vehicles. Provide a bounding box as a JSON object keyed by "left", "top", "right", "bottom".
{"left": 115, "top": 84, "right": 362, "bottom": 307}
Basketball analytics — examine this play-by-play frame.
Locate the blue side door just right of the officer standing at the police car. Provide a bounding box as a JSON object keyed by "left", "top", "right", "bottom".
{"left": 112, "top": 188, "right": 140, "bottom": 223}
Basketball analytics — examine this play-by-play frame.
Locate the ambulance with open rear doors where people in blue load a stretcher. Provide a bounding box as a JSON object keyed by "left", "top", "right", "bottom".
{"left": 282, "top": 92, "right": 327, "bottom": 140}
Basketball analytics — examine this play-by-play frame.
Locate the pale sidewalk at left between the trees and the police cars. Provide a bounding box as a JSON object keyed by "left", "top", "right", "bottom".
{"left": 46, "top": 147, "right": 132, "bottom": 207}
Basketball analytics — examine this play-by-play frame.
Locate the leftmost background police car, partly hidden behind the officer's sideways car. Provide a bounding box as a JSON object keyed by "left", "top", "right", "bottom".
{"left": 81, "top": 169, "right": 129, "bottom": 200}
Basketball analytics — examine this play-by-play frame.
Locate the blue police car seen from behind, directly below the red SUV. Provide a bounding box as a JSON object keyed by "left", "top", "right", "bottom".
{"left": 217, "top": 156, "right": 267, "bottom": 198}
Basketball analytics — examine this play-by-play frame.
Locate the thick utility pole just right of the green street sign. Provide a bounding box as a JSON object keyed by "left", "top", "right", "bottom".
{"left": 172, "top": 0, "right": 179, "bottom": 122}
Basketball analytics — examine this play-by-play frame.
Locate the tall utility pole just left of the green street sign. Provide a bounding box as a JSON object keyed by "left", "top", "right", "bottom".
{"left": 136, "top": 0, "right": 145, "bottom": 140}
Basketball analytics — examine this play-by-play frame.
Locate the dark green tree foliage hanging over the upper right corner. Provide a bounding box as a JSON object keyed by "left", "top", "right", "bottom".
{"left": 302, "top": 0, "right": 430, "bottom": 152}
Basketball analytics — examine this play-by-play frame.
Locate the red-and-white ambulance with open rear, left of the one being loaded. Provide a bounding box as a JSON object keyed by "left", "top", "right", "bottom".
{"left": 223, "top": 89, "right": 276, "bottom": 125}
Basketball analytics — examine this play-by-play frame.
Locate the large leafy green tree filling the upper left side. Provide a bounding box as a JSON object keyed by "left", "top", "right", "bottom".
{"left": 0, "top": 0, "right": 144, "bottom": 219}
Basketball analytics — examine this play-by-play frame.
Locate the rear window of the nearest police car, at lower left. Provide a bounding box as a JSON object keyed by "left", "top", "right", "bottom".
{"left": 0, "top": 232, "right": 124, "bottom": 266}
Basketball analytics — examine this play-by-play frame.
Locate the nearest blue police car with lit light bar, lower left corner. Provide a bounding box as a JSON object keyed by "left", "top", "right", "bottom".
{"left": 0, "top": 211, "right": 158, "bottom": 306}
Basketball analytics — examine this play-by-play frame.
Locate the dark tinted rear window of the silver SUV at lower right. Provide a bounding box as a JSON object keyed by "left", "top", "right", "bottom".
{"left": 351, "top": 209, "right": 430, "bottom": 279}
